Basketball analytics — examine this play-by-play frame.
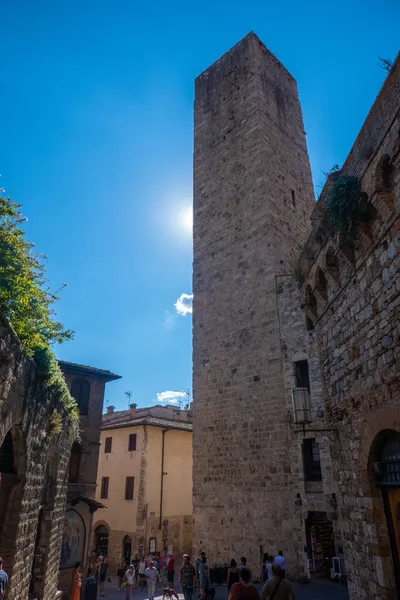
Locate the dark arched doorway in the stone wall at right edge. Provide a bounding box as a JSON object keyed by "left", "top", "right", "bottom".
{"left": 374, "top": 429, "right": 400, "bottom": 598}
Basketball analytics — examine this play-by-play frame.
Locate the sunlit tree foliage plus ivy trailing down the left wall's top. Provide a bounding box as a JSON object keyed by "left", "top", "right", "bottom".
{"left": 0, "top": 196, "right": 79, "bottom": 436}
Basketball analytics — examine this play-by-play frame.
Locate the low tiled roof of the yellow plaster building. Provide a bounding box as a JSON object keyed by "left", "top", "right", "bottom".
{"left": 101, "top": 405, "right": 193, "bottom": 431}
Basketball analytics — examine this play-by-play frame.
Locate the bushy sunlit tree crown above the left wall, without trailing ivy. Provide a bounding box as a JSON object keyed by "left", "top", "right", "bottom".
{"left": 0, "top": 197, "right": 73, "bottom": 355}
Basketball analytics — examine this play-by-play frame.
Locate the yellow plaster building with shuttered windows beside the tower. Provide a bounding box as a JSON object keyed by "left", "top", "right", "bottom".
{"left": 93, "top": 404, "right": 192, "bottom": 568}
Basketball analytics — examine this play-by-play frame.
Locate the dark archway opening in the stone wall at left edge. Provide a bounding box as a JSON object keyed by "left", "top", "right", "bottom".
{"left": 0, "top": 425, "right": 26, "bottom": 579}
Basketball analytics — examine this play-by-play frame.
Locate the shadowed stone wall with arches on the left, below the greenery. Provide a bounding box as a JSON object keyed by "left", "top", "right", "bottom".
{"left": 0, "top": 315, "right": 71, "bottom": 600}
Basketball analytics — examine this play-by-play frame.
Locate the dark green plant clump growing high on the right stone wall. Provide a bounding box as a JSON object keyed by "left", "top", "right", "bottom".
{"left": 325, "top": 175, "right": 363, "bottom": 247}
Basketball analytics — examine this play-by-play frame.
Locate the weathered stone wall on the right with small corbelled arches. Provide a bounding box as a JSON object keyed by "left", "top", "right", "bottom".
{"left": 300, "top": 54, "right": 400, "bottom": 600}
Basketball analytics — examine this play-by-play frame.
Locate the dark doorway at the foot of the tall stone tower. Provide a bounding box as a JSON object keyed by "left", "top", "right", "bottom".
{"left": 306, "top": 511, "right": 336, "bottom": 579}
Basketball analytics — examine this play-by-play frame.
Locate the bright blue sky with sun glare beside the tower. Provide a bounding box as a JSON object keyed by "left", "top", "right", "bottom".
{"left": 0, "top": 0, "right": 400, "bottom": 409}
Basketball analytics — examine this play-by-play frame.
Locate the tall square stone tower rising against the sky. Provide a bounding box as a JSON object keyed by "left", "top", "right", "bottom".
{"left": 193, "top": 33, "right": 314, "bottom": 567}
